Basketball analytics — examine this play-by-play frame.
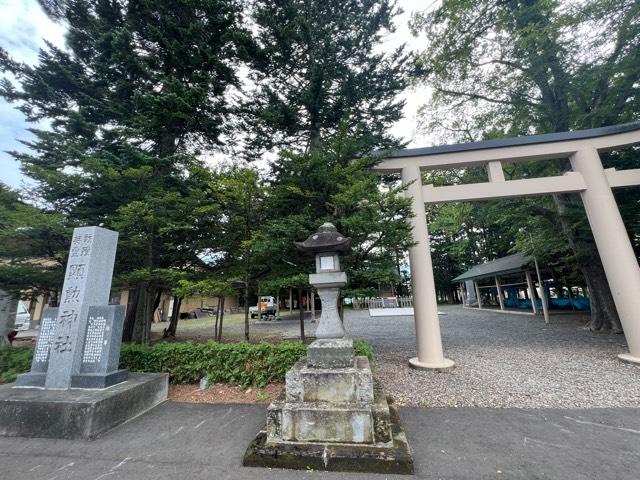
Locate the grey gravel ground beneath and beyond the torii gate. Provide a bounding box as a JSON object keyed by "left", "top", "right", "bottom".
{"left": 345, "top": 307, "right": 640, "bottom": 408}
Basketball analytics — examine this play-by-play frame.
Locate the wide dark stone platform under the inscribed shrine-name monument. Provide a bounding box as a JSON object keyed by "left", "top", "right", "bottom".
{"left": 0, "top": 373, "right": 169, "bottom": 439}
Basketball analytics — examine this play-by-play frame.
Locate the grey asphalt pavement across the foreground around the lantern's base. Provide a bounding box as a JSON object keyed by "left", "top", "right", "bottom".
{"left": 0, "top": 402, "right": 640, "bottom": 480}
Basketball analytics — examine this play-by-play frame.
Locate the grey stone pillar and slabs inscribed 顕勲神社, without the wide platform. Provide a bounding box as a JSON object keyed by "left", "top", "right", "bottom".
{"left": 17, "top": 227, "right": 127, "bottom": 389}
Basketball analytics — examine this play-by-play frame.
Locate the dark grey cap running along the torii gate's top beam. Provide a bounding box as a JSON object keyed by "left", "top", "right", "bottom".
{"left": 380, "top": 122, "right": 640, "bottom": 158}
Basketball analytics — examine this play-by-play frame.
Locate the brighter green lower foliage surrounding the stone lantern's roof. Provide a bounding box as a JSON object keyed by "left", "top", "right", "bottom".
{"left": 254, "top": 128, "right": 412, "bottom": 293}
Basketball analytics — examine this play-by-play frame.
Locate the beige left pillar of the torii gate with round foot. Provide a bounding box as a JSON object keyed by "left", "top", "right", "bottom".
{"left": 402, "top": 165, "right": 455, "bottom": 370}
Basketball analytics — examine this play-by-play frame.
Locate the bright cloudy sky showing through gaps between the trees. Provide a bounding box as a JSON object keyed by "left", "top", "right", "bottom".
{"left": 0, "top": 0, "right": 431, "bottom": 187}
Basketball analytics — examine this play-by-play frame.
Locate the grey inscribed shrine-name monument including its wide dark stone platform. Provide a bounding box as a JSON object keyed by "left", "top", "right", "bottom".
{"left": 0, "top": 227, "right": 168, "bottom": 438}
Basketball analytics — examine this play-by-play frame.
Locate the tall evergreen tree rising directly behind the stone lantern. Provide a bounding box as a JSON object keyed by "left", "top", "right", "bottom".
{"left": 245, "top": 0, "right": 410, "bottom": 294}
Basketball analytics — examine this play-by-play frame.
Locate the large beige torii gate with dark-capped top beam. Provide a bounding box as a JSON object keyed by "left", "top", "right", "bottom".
{"left": 375, "top": 122, "right": 640, "bottom": 369}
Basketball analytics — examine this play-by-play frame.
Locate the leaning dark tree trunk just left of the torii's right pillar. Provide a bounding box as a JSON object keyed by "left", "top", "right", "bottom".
{"left": 553, "top": 189, "right": 622, "bottom": 333}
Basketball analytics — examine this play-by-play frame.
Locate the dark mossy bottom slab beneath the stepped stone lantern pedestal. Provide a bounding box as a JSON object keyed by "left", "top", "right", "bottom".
{"left": 242, "top": 405, "right": 413, "bottom": 475}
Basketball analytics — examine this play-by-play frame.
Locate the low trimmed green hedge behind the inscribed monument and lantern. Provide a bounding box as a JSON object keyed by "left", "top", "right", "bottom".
{"left": 0, "top": 340, "right": 373, "bottom": 387}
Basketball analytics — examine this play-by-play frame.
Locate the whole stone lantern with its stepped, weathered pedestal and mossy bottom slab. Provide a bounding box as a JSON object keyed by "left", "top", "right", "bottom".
{"left": 244, "top": 223, "right": 413, "bottom": 474}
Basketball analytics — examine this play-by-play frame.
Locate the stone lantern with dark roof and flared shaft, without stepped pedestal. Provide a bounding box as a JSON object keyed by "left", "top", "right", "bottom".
{"left": 295, "top": 223, "right": 351, "bottom": 339}
